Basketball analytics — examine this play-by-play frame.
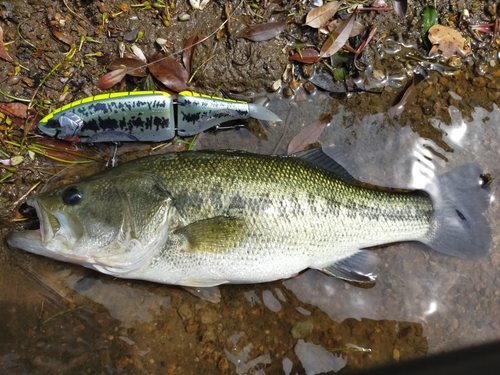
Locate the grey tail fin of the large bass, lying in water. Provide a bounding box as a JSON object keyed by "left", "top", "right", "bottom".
{"left": 422, "top": 164, "right": 491, "bottom": 259}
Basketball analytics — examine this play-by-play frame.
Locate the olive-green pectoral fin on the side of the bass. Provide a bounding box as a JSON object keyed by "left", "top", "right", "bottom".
{"left": 175, "top": 216, "right": 246, "bottom": 253}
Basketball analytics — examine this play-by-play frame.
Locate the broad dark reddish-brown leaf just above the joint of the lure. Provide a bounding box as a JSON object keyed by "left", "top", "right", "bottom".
{"left": 149, "top": 53, "right": 192, "bottom": 92}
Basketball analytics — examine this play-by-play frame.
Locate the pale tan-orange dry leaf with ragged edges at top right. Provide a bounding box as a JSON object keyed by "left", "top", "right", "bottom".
{"left": 428, "top": 25, "right": 472, "bottom": 59}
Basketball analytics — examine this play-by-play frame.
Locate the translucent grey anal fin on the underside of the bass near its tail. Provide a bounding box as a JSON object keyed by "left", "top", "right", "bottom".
{"left": 320, "top": 250, "right": 379, "bottom": 283}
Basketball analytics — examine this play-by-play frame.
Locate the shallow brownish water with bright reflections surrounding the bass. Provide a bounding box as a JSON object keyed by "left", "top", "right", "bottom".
{"left": 0, "top": 70, "right": 500, "bottom": 374}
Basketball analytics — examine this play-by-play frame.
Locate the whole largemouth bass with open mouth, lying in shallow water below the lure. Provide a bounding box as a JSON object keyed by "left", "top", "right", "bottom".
{"left": 7, "top": 149, "right": 491, "bottom": 287}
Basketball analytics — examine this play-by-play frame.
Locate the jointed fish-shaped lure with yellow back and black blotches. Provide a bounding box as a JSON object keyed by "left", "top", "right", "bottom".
{"left": 38, "top": 91, "right": 281, "bottom": 143}
